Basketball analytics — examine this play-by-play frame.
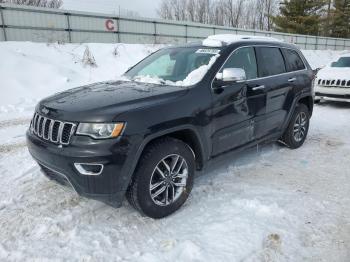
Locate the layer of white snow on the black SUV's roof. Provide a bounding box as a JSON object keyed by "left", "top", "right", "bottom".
{"left": 202, "top": 34, "right": 282, "bottom": 47}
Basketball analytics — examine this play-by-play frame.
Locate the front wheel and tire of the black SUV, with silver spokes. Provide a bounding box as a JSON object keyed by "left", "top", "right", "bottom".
{"left": 126, "top": 137, "right": 195, "bottom": 218}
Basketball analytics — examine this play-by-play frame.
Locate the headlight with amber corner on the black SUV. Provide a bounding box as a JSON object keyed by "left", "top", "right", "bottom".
{"left": 77, "top": 123, "right": 125, "bottom": 139}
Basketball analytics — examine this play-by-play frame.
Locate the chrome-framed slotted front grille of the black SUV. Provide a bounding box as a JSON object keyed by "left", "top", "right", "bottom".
{"left": 30, "top": 113, "right": 76, "bottom": 145}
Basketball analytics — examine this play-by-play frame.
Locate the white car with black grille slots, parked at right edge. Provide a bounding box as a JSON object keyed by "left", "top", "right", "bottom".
{"left": 315, "top": 54, "right": 350, "bottom": 102}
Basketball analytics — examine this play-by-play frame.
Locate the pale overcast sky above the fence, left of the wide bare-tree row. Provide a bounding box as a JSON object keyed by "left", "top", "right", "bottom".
{"left": 62, "top": 0, "right": 161, "bottom": 18}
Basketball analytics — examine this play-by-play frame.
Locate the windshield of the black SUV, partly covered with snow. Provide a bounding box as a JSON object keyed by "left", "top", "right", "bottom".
{"left": 125, "top": 47, "right": 220, "bottom": 86}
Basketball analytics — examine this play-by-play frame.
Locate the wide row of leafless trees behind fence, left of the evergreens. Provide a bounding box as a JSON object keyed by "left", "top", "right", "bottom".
{"left": 158, "top": 0, "right": 279, "bottom": 30}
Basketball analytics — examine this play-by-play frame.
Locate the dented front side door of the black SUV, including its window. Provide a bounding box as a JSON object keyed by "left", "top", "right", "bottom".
{"left": 212, "top": 47, "right": 265, "bottom": 156}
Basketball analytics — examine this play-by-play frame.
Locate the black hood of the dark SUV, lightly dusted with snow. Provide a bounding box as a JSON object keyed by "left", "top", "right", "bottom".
{"left": 37, "top": 81, "right": 187, "bottom": 122}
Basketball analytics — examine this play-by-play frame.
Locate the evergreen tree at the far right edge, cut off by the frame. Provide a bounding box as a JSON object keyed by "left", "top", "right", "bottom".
{"left": 331, "top": 0, "right": 350, "bottom": 38}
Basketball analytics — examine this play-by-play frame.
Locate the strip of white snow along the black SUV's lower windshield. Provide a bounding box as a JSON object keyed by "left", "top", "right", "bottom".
{"left": 133, "top": 54, "right": 220, "bottom": 86}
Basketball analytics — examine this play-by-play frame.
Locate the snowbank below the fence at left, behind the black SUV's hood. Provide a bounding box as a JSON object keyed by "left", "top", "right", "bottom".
{"left": 0, "top": 42, "right": 161, "bottom": 112}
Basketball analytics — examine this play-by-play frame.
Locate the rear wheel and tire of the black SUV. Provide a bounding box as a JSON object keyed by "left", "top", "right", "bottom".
{"left": 281, "top": 104, "right": 310, "bottom": 149}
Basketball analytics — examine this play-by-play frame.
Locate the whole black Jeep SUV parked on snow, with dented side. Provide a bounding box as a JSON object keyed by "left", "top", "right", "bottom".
{"left": 27, "top": 37, "right": 314, "bottom": 218}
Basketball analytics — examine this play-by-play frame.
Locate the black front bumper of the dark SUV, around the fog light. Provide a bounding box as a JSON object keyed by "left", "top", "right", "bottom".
{"left": 26, "top": 130, "right": 140, "bottom": 207}
